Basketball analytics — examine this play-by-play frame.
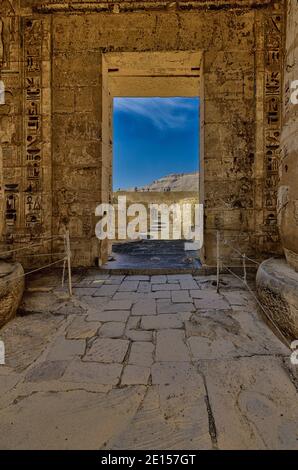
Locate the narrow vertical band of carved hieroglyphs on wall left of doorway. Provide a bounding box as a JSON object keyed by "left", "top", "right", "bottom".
{"left": 24, "top": 18, "right": 43, "bottom": 232}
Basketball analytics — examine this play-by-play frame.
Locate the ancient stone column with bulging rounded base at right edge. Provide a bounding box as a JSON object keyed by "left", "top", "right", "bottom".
{"left": 257, "top": 0, "right": 298, "bottom": 339}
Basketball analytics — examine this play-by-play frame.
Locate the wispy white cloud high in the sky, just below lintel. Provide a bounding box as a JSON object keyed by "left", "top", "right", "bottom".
{"left": 114, "top": 98, "right": 197, "bottom": 130}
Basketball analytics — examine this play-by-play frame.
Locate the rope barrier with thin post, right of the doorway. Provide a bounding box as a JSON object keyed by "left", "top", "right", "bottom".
{"left": 216, "top": 231, "right": 291, "bottom": 350}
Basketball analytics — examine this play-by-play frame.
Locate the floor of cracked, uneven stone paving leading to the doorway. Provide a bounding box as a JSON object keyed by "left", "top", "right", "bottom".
{"left": 0, "top": 270, "right": 298, "bottom": 449}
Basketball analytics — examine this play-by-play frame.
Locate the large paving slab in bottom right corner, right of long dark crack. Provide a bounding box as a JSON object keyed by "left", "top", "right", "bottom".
{"left": 200, "top": 357, "right": 298, "bottom": 450}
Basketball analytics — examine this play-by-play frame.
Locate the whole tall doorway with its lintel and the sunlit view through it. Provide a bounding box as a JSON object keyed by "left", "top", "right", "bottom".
{"left": 102, "top": 52, "right": 201, "bottom": 273}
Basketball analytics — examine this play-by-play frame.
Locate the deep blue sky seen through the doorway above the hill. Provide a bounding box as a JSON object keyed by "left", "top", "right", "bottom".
{"left": 113, "top": 97, "right": 199, "bottom": 190}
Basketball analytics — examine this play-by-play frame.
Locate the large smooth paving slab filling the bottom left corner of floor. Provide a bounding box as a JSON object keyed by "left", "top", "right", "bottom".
{"left": 0, "top": 386, "right": 145, "bottom": 450}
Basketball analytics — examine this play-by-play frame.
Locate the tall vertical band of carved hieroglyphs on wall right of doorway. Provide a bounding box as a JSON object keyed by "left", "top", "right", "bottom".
{"left": 263, "top": 12, "right": 283, "bottom": 249}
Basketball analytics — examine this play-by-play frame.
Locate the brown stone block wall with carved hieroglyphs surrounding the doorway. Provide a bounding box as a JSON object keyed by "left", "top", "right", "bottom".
{"left": 0, "top": 0, "right": 283, "bottom": 266}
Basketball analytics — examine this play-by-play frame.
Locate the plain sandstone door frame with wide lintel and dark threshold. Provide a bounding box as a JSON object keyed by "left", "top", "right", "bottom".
{"left": 100, "top": 51, "right": 203, "bottom": 270}
